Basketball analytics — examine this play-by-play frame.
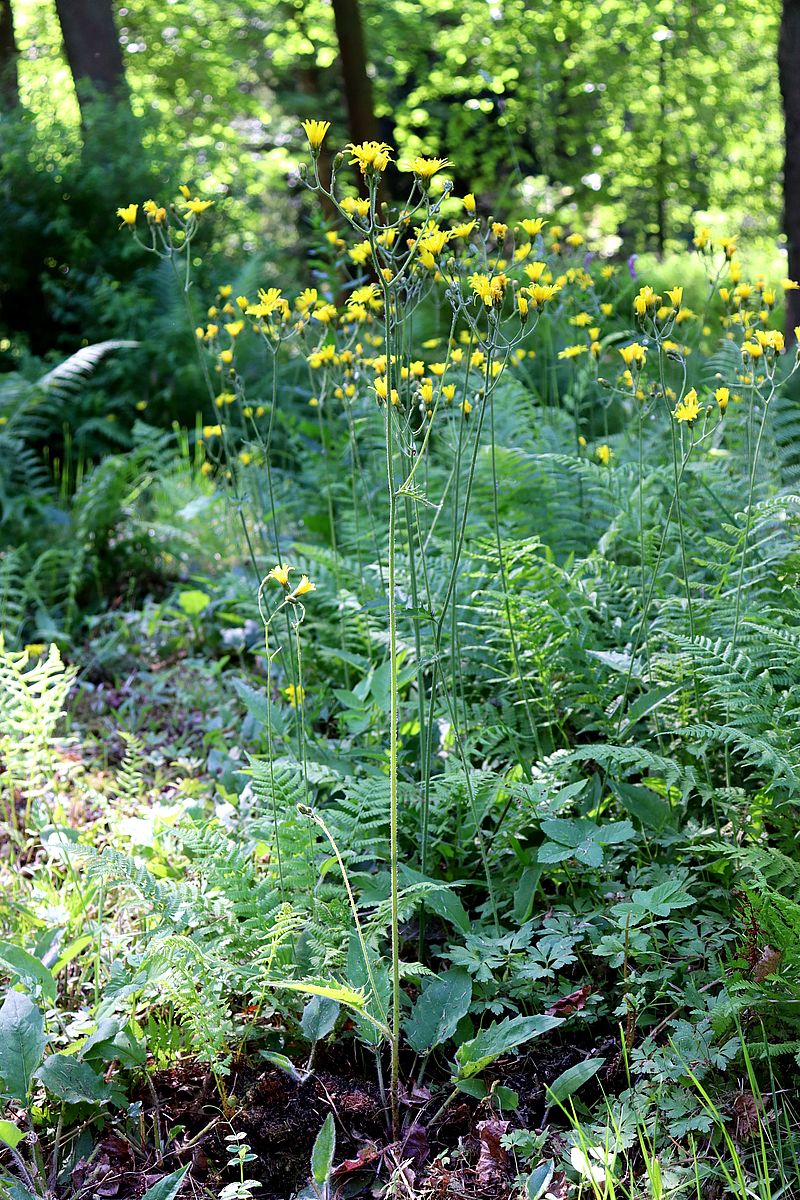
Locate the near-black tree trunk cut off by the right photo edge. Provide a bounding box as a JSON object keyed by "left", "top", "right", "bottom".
{"left": 777, "top": 0, "right": 800, "bottom": 340}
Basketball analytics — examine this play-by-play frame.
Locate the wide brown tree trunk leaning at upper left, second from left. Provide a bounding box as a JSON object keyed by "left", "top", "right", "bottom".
{"left": 55, "top": 0, "right": 126, "bottom": 115}
